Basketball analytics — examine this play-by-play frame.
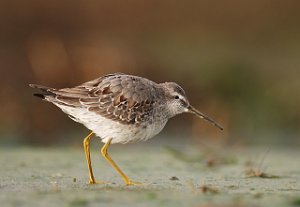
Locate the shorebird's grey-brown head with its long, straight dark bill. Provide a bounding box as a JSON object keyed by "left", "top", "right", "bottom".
{"left": 161, "top": 82, "right": 223, "bottom": 130}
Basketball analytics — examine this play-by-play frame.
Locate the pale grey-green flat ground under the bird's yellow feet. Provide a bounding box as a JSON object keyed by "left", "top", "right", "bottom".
{"left": 0, "top": 145, "right": 300, "bottom": 207}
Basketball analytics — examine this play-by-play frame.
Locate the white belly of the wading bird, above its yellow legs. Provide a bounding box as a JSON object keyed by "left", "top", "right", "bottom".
{"left": 56, "top": 106, "right": 167, "bottom": 144}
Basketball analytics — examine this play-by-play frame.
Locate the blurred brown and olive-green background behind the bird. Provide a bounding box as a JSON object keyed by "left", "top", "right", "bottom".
{"left": 0, "top": 0, "right": 300, "bottom": 146}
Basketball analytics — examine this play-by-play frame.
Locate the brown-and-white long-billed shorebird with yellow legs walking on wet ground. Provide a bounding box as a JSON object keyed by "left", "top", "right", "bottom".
{"left": 29, "top": 73, "right": 223, "bottom": 185}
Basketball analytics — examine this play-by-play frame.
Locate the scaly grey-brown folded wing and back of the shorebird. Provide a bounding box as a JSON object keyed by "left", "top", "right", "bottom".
{"left": 50, "top": 74, "right": 162, "bottom": 124}
